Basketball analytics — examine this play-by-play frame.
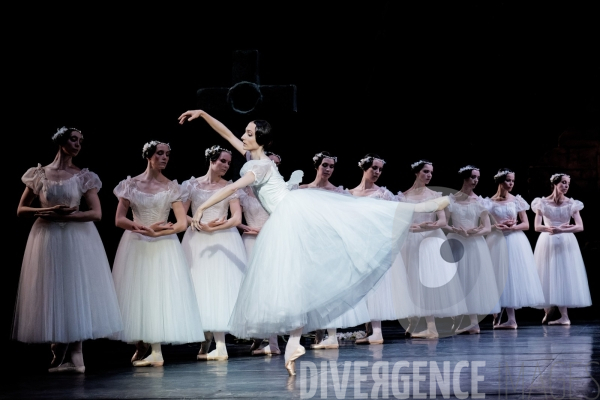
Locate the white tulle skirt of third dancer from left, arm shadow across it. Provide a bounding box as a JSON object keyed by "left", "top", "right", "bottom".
{"left": 181, "top": 228, "right": 246, "bottom": 332}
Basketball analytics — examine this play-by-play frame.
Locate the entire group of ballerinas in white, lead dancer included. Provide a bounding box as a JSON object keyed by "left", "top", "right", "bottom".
{"left": 13, "top": 110, "right": 591, "bottom": 375}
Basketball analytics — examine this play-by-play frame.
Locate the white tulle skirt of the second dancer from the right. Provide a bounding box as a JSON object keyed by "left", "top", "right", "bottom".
{"left": 486, "top": 231, "right": 544, "bottom": 308}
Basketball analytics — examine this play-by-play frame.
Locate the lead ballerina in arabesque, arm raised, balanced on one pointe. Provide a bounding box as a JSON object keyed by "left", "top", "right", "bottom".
{"left": 179, "top": 110, "right": 448, "bottom": 376}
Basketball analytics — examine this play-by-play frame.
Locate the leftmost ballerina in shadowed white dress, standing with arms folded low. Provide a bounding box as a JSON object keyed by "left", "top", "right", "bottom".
{"left": 12, "top": 127, "right": 123, "bottom": 373}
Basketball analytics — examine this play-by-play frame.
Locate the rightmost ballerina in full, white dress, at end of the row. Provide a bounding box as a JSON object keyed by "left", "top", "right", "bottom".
{"left": 531, "top": 173, "right": 592, "bottom": 325}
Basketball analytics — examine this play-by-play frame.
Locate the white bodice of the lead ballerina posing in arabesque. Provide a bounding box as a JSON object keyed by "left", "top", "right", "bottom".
{"left": 240, "top": 159, "right": 302, "bottom": 214}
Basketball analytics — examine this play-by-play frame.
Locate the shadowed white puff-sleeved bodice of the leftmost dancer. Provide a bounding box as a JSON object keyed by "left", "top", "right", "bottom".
{"left": 21, "top": 164, "right": 102, "bottom": 207}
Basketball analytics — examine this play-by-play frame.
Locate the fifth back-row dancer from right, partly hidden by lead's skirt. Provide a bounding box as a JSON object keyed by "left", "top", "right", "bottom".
{"left": 349, "top": 153, "right": 408, "bottom": 344}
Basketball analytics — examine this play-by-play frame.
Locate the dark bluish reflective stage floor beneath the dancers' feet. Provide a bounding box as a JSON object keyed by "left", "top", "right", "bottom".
{"left": 0, "top": 320, "right": 600, "bottom": 399}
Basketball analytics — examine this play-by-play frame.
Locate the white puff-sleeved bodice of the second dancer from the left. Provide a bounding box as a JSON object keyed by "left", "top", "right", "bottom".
{"left": 113, "top": 176, "right": 181, "bottom": 226}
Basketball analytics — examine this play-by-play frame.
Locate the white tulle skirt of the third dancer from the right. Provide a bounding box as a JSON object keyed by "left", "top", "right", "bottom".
{"left": 448, "top": 233, "right": 500, "bottom": 315}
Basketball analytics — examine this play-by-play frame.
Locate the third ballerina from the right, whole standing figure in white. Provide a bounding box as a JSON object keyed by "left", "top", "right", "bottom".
{"left": 446, "top": 166, "right": 500, "bottom": 334}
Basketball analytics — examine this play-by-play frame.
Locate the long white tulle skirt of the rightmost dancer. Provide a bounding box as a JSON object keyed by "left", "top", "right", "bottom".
{"left": 534, "top": 232, "right": 592, "bottom": 307}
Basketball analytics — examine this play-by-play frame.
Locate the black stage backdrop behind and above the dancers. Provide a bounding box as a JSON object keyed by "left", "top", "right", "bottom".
{"left": 5, "top": 1, "right": 600, "bottom": 339}
